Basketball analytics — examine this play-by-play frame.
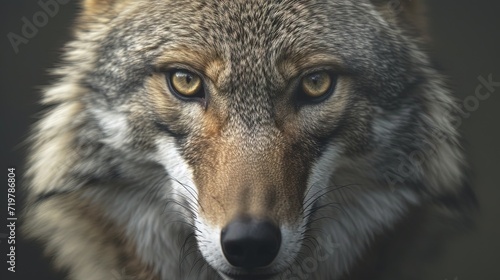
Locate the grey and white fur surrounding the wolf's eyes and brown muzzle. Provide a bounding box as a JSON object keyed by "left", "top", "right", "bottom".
{"left": 25, "top": 0, "right": 476, "bottom": 279}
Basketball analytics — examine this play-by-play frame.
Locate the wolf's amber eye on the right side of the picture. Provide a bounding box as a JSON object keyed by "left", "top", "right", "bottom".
{"left": 300, "top": 71, "right": 336, "bottom": 101}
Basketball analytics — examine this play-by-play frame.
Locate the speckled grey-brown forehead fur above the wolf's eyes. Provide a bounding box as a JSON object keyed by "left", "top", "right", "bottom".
{"left": 82, "top": 0, "right": 411, "bottom": 99}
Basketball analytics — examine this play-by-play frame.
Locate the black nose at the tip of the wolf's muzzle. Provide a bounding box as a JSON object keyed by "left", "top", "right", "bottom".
{"left": 221, "top": 217, "right": 281, "bottom": 269}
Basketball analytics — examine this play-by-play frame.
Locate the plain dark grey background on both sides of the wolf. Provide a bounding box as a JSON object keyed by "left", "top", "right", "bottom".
{"left": 0, "top": 0, "right": 500, "bottom": 280}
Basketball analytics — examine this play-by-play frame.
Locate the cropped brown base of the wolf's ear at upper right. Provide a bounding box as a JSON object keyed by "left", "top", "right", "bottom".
{"left": 370, "top": 0, "right": 427, "bottom": 34}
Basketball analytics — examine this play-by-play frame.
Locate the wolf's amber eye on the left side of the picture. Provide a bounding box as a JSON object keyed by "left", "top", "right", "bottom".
{"left": 169, "top": 70, "right": 203, "bottom": 97}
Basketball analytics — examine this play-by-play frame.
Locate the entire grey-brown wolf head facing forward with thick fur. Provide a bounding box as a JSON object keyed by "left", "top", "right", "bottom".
{"left": 27, "top": 0, "right": 472, "bottom": 279}
